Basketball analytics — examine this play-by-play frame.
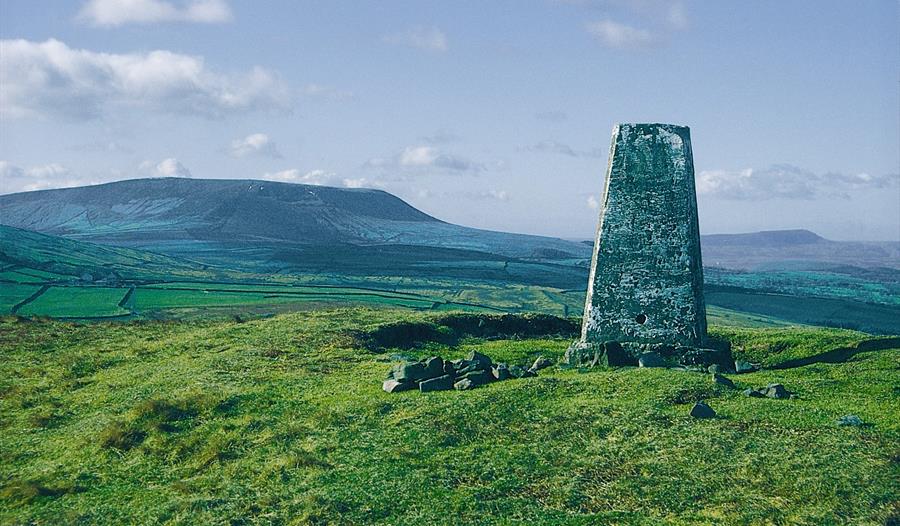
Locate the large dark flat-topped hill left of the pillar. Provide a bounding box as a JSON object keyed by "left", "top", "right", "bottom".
{"left": 0, "top": 178, "right": 590, "bottom": 266}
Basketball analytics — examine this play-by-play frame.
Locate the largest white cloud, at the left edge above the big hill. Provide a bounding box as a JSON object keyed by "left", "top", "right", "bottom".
{"left": 0, "top": 39, "right": 290, "bottom": 120}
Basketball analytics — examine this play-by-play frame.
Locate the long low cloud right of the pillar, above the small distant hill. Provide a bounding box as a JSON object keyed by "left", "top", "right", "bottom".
{"left": 697, "top": 164, "right": 900, "bottom": 200}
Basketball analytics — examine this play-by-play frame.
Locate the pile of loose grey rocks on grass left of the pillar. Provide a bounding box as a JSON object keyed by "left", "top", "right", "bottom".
{"left": 382, "top": 351, "right": 553, "bottom": 393}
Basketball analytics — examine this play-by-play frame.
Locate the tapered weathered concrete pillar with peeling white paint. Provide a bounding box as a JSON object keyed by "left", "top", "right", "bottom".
{"left": 567, "top": 124, "right": 707, "bottom": 365}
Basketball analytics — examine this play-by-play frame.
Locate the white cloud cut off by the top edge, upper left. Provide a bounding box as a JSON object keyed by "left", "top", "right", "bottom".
{"left": 78, "top": 0, "right": 233, "bottom": 27}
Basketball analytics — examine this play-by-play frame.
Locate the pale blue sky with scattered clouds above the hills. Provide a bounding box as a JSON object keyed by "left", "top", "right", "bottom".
{"left": 0, "top": 0, "right": 900, "bottom": 241}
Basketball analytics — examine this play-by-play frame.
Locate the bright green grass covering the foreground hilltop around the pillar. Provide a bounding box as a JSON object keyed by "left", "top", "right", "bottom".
{"left": 0, "top": 308, "right": 900, "bottom": 524}
